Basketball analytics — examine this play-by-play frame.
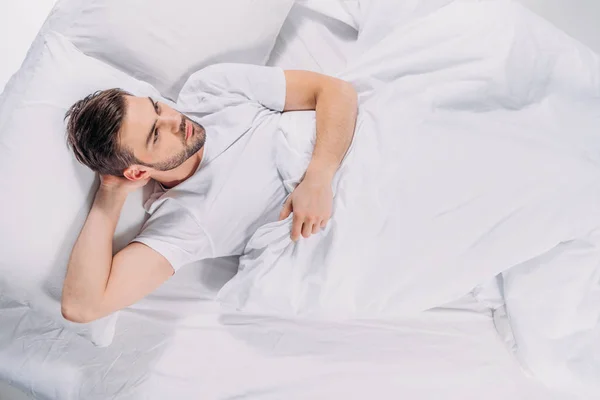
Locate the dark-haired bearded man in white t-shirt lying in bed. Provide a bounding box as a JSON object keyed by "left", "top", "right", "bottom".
{"left": 62, "top": 64, "right": 357, "bottom": 322}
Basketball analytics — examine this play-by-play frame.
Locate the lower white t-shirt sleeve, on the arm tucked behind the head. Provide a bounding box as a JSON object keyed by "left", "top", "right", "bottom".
{"left": 131, "top": 200, "right": 213, "bottom": 271}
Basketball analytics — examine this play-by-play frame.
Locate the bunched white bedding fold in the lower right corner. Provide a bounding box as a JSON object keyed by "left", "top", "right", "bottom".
{"left": 502, "top": 230, "right": 600, "bottom": 399}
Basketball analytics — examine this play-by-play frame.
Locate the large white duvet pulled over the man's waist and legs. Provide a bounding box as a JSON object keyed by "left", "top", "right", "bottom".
{"left": 219, "top": 0, "right": 600, "bottom": 394}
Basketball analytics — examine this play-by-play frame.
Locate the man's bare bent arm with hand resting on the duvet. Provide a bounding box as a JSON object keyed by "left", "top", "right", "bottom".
{"left": 279, "top": 70, "right": 358, "bottom": 241}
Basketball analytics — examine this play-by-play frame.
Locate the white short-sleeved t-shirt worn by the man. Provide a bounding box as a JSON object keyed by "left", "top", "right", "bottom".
{"left": 132, "top": 63, "right": 287, "bottom": 271}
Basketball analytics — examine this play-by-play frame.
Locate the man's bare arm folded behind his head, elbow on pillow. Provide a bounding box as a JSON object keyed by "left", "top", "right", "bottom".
{"left": 61, "top": 177, "right": 173, "bottom": 322}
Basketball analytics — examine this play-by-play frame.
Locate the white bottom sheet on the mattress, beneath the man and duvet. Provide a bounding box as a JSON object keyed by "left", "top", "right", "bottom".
{"left": 0, "top": 1, "right": 596, "bottom": 400}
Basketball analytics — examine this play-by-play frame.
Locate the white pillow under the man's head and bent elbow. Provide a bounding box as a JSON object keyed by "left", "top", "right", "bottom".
{"left": 0, "top": 32, "right": 171, "bottom": 346}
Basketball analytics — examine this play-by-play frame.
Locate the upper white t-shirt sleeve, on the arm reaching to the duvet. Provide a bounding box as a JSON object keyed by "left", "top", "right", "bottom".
{"left": 177, "top": 63, "right": 286, "bottom": 111}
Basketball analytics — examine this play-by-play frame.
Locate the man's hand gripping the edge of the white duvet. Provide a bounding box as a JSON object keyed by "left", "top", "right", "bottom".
{"left": 279, "top": 177, "right": 333, "bottom": 242}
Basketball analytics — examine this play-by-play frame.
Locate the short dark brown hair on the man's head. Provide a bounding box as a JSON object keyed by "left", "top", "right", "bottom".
{"left": 65, "top": 89, "right": 135, "bottom": 176}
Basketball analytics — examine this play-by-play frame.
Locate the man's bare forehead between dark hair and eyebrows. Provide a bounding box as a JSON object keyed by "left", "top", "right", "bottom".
{"left": 120, "top": 96, "right": 156, "bottom": 149}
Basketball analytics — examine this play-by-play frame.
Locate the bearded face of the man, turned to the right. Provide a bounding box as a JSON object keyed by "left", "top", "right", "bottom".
{"left": 120, "top": 96, "right": 206, "bottom": 171}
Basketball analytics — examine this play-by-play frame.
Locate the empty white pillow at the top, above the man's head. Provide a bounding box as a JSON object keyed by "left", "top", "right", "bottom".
{"left": 52, "top": 0, "right": 293, "bottom": 100}
